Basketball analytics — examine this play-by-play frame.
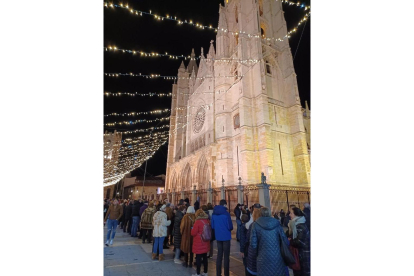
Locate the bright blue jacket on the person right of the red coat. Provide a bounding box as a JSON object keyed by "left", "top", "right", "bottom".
{"left": 211, "top": 205, "right": 233, "bottom": 241}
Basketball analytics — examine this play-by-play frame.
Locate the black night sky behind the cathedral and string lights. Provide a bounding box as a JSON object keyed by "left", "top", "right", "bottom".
{"left": 103, "top": 0, "right": 311, "bottom": 176}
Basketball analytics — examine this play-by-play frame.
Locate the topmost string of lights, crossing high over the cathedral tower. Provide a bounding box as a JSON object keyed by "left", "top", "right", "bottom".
{"left": 104, "top": 0, "right": 310, "bottom": 41}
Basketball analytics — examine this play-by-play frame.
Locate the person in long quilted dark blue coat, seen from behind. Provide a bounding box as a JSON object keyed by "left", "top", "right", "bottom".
{"left": 249, "top": 207, "right": 289, "bottom": 276}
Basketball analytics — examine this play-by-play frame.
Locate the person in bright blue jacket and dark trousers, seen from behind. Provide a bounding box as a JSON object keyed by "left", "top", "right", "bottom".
{"left": 211, "top": 199, "right": 233, "bottom": 276}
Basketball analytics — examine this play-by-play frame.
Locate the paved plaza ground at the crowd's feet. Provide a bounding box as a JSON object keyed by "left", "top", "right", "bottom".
{"left": 103, "top": 221, "right": 293, "bottom": 276}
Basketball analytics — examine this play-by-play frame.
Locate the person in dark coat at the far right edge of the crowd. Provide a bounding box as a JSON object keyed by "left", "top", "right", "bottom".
{"left": 289, "top": 208, "right": 310, "bottom": 276}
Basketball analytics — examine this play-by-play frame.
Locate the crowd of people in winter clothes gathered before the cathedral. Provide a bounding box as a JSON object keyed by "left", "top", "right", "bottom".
{"left": 104, "top": 198, "right": 310, "bottom": 276}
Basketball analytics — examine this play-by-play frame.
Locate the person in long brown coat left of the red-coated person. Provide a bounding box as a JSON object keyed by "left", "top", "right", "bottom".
{"left": 180, "top": 206, "right": 195, "bottom": 268}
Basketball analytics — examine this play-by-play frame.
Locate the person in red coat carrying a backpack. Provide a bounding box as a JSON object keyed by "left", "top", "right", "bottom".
{"left": 191, "top": 209, "right": 211, "bottom": 276}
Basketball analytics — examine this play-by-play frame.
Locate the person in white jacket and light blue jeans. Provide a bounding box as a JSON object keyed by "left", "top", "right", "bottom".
{"left": 152, "top": 205, "right": 171, "bottom": 261}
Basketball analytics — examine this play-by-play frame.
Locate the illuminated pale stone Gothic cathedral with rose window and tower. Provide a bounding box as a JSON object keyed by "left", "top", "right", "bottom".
{"left": 165, "top": 0, "right": 310, "bottom": 192}
